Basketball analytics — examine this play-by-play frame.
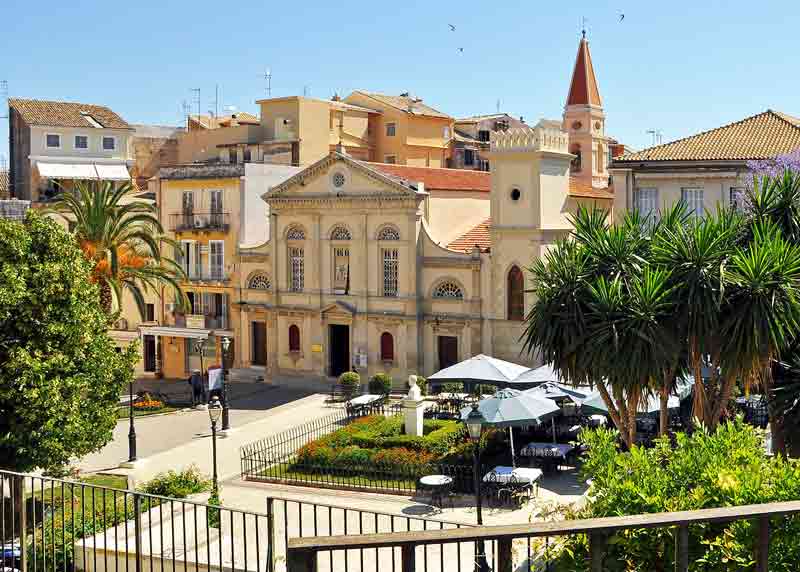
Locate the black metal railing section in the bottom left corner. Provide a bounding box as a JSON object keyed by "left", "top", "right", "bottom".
{"left": 0, "top": 471, "right": 275, "bottom": 572}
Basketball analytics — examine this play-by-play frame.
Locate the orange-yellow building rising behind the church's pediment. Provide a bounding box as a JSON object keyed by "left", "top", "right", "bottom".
{"left": 344, "top": 90, "right": 454, "bottom": 167}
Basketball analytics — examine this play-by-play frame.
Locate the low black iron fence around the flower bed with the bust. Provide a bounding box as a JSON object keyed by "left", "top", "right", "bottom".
{"left": 240, "top": 403, "right": 484, "bottom": 494}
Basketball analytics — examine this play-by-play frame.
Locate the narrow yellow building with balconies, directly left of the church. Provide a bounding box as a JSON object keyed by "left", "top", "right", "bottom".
{"left": 140, "top": 164, "right": 244, "bottom": 378}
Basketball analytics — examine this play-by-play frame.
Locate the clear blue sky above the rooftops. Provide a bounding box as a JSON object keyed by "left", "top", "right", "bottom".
{"left": 0, "top": 0, "right": 800, "bottom": 162}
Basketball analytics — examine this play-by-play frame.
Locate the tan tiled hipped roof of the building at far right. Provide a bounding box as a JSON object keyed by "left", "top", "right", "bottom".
{"left": 614, "top": 109, "right": 800, "bottom": 163}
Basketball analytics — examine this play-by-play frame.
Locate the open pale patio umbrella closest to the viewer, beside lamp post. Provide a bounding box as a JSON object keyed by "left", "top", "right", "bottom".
{"left": 461, "top": 388, "right": 560, "bottom": 467}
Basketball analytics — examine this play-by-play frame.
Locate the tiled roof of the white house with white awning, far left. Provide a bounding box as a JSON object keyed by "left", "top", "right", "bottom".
{"left": 8, "top": 97, "right": 133, "bottom": 129}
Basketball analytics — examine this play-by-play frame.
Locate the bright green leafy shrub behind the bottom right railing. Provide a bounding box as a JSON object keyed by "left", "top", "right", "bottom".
{"left": 557, "top": 419, "right": 800, "bottom": 572}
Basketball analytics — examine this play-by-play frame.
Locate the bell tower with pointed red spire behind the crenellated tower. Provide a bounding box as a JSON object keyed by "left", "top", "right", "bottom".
{"left": 562, "top": 30, "right": 608, "bottom": 188}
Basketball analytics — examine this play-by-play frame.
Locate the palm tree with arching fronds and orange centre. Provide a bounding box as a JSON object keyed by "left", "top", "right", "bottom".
{"left": 49, "top": 181, "right": 185, "bottom": 319}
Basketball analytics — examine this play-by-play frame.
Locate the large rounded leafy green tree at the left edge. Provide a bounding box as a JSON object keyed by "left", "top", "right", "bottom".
{"left": 0, "top": 211, "right": 138, "bottom": 471}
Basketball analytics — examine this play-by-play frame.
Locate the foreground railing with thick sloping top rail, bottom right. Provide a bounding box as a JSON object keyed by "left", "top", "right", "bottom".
{"left": 287, "top": 501, "right": 800, "bottom": 572}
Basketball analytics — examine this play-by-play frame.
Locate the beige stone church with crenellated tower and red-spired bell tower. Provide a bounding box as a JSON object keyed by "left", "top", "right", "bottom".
{"left": 225, "top": 38, "right": 613, "bottom": 380}
